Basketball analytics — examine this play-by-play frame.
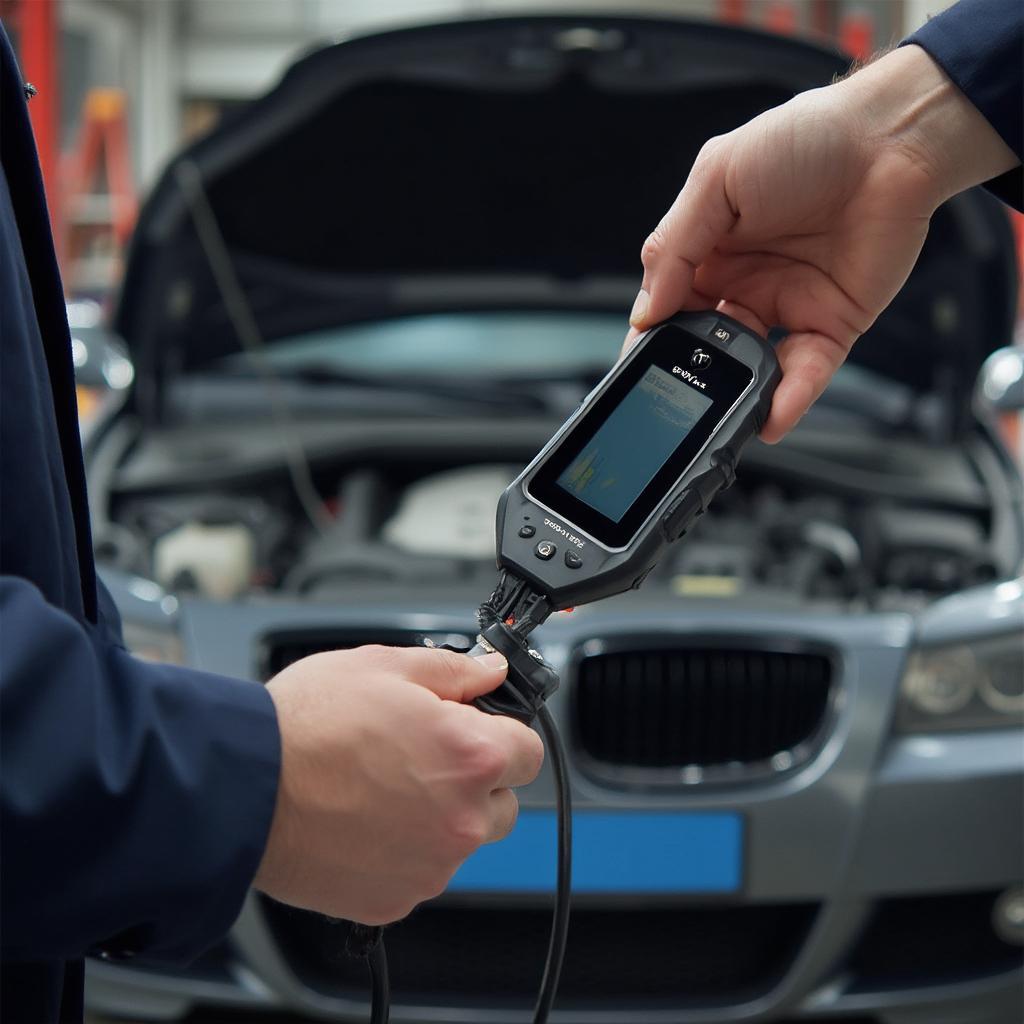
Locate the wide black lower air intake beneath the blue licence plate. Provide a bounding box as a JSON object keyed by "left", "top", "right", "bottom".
{"left": 260, "top": 897, "right": 816, "bottom": 1011}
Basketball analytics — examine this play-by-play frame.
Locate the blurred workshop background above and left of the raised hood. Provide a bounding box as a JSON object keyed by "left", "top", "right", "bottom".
{"left": 0, "top": 0, "right": 1015, "bottom": 292}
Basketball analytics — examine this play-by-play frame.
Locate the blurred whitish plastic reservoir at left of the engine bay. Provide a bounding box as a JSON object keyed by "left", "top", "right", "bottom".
{"left": 153, "top": 520, "right": 255, "bottom": 601}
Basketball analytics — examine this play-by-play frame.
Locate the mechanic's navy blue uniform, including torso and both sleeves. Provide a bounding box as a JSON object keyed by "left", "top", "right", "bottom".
{"left": 0, "top": 0, "right": 1024, "bottom": 1024}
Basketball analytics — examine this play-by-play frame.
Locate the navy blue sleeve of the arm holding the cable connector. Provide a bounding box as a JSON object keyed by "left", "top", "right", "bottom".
{"left": 0, "top": 577, "right": 281, "bottom": 962}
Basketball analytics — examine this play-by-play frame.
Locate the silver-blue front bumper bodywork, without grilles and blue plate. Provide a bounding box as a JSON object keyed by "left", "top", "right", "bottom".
{"left": 87, "top": 598, "right": 1024, "bottom": 1024}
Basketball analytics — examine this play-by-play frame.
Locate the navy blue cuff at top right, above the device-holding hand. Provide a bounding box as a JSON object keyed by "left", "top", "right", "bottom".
{"left": 902, "top": 0, "right": 1024, "bottom": 210}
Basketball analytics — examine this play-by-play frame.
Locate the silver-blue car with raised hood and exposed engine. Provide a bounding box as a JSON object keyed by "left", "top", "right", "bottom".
{"left": 86, "top": 14, "right": 1024, "bottom": 1024}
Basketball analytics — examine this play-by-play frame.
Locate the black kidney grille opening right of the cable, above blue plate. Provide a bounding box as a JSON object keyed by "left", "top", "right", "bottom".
{"left": 572, "top": 647, "right": 831, "bottom": 769}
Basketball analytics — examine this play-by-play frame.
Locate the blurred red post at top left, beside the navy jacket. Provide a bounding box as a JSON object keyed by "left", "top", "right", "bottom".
{"left": 14, "top": 0, "right": 60, "bottom": 238}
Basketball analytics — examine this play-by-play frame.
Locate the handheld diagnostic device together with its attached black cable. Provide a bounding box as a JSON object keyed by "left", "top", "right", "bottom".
{"left": 349, "top": 310, "right": 781, "bottom": 1024}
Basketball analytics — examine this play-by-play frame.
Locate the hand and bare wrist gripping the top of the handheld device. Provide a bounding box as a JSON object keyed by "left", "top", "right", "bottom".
{"left": 626, "top": 46, "right": 1018, "bottom": 441}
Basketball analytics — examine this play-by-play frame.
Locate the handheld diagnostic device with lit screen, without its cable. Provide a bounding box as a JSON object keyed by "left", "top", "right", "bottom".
{"left": 498, "top": 312, "right": 781, "bottom": 610}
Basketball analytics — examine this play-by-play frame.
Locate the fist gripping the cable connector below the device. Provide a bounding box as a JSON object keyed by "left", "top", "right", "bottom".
{"left": 255, "top": 647, "right": 544, "bottom": 925}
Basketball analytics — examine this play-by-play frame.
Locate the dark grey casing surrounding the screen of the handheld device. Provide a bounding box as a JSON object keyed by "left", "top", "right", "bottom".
{"left": 497, "top": 311, "right": 782, "bottom": 609}
